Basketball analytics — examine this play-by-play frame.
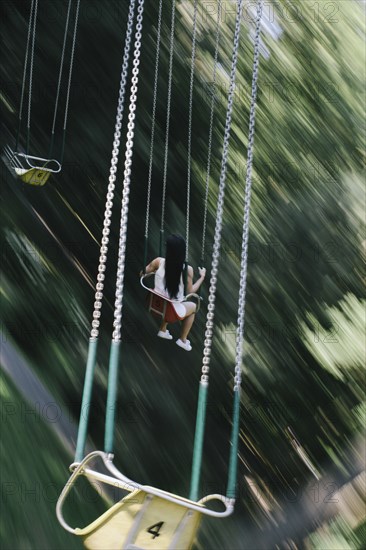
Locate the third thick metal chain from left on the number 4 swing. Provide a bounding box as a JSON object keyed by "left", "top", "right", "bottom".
{"left": 201, "top": 0, "right": 244, "bottom": 385}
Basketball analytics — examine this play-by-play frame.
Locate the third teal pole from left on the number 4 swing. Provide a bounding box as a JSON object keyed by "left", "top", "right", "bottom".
{"left": 189, "top": 382, "right": 208, "bottom": 502}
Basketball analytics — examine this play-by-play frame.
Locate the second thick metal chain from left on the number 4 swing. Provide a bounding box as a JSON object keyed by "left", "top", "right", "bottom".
{"left": 112, "top": 0, "right": 144, "bottom": 342}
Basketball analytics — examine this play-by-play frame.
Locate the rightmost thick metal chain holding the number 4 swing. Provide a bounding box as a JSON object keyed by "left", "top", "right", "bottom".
{"left": 234, "top": 0, "right": 263, "bottom": 391}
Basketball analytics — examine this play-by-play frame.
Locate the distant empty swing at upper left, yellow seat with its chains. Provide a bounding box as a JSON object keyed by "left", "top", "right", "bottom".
{"left": 4, "top": 0, "right": 80, "bottom": 186}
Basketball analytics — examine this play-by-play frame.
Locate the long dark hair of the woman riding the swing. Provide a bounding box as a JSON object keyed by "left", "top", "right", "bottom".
{"left": 165, "top": 235, "right": 186, "bottom": 299}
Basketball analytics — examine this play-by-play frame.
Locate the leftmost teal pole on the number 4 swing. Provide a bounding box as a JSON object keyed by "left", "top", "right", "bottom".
{"left": 75, "top": 338, "right": 98, "bottom": 462}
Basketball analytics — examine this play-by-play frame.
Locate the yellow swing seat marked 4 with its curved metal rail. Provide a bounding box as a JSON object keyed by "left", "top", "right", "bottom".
{"left": 56, "top": 451, "right": 234, "bottom": 550}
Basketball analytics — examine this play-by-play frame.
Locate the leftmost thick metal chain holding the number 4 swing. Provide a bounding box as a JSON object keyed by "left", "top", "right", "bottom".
{"left": 90, "top": 0, "right": 136, "bottom": 339}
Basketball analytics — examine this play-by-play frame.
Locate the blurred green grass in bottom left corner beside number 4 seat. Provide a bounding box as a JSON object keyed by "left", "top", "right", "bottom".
{"left": 0, "top": 374, "right": 84, "bottom": 549}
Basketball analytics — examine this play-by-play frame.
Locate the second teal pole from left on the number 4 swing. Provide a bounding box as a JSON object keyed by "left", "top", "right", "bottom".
{"left": 104, "top": 340, "right": 120, "bottom": 453}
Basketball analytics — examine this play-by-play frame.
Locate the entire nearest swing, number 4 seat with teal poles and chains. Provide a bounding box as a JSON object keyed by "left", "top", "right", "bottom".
{"left": 56, "top": 0, "right": 263, "bottom": 550}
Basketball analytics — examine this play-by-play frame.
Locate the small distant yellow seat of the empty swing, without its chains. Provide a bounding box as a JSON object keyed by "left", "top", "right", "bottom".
{"left": 4, "top": 146, "right": 61, "bottom": 186}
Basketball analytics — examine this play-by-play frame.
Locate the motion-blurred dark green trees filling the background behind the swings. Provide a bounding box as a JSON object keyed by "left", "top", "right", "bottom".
{"left": 0, "top": 0, "right": 366, "bottom": 549}
